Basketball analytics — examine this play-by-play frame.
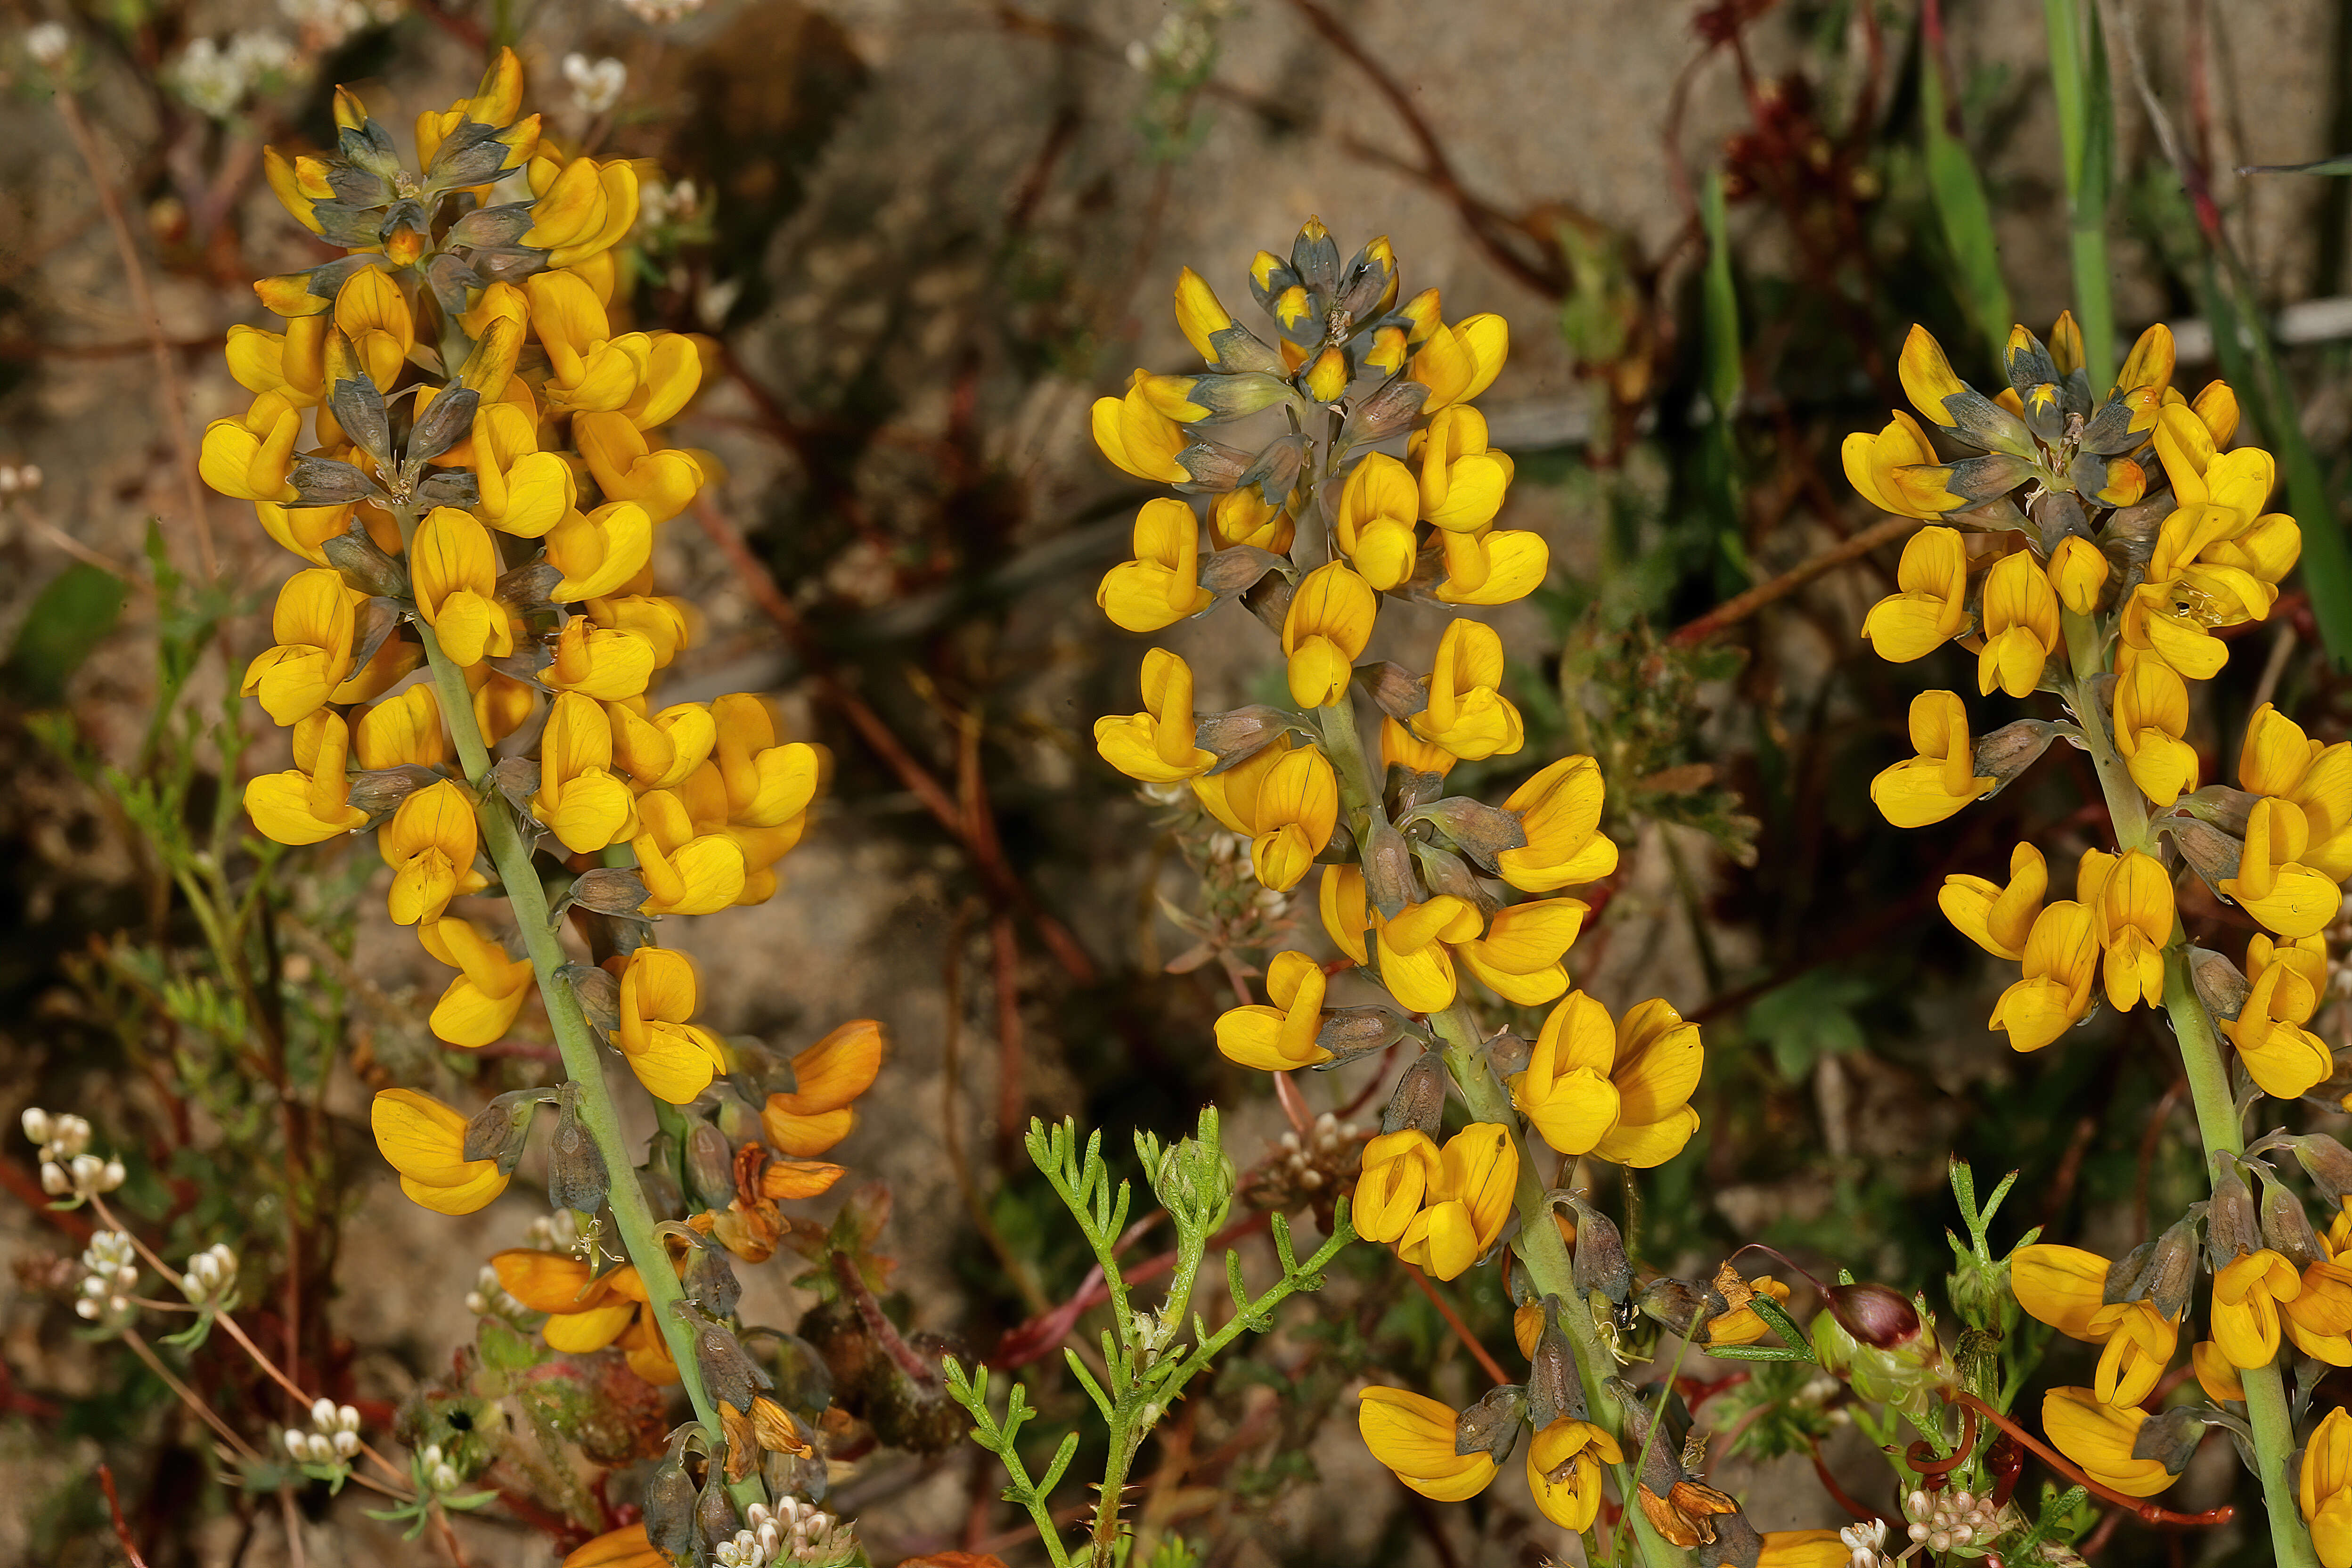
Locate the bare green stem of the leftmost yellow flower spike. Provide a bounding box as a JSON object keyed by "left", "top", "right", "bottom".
{"left": 402, "top": 573, "right": 767, "bottom": 1507}
